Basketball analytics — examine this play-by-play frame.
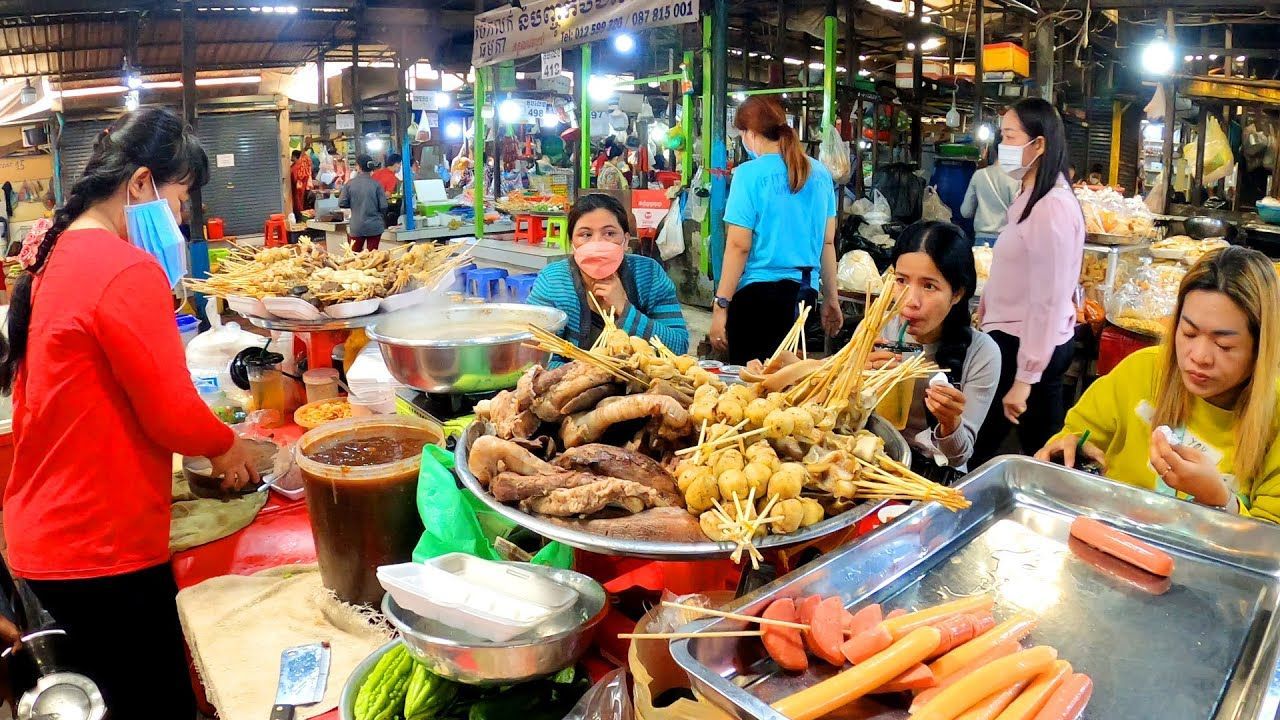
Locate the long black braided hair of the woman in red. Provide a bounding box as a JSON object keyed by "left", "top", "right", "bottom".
{"left": 0, "top": 108, "right": 209, "bottom": 393}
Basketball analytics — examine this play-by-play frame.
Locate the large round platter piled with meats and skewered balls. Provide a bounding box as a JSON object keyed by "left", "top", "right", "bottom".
{"left": 457, "top": 277, "right": 968, "bottom": 562}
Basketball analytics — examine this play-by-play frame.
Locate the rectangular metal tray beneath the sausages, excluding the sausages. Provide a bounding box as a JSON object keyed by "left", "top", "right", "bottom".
{"left": 671, "top": 457, "right": 1280, "bottom": 720}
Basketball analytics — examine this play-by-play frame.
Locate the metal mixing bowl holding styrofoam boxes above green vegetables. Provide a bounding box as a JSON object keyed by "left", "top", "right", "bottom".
{"left": 383, "top": 564, "right": 608, "bottom": 685}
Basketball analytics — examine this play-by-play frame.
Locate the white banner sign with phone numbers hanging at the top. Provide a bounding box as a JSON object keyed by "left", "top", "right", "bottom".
{"left": 471, "top": 0, "right": 699, "bottom": 68}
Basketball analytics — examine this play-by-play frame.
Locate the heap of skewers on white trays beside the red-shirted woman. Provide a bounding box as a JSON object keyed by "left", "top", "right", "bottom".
{"left": 186, "top": 240, "right": 470, "bottom": 322}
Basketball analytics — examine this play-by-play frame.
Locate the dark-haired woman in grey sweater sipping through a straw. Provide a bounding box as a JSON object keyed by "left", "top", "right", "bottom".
{"left": 870, "top": 222, "right": 1000, "bottom": 479}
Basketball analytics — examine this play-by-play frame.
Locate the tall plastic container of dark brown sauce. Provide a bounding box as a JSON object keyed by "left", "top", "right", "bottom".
{"left": 294, "top": 415, "right": 444, "bottom": 606}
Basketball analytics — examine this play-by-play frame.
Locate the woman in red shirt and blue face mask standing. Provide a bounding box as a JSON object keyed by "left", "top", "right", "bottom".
{"left": 0, "top": 108, "right": 256, "bottom": 720}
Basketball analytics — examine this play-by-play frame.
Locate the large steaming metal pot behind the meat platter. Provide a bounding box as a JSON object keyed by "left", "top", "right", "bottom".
{"left": 366, "top": 304, "right": 567, "bottom": 393}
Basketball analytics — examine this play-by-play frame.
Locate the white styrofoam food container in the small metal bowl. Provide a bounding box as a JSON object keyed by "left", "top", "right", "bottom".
{"left": 378, "top": 552, "right": 577, "bottom": 642}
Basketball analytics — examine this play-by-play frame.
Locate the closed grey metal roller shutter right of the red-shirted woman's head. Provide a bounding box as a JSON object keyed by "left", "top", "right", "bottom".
{"left": 197, "top": 113, "right": 282, "bottom": 234}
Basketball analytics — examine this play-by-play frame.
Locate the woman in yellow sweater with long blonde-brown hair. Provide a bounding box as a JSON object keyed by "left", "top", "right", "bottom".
{"left": 1036, "top": 247, "right": 1280, "bottom": 523}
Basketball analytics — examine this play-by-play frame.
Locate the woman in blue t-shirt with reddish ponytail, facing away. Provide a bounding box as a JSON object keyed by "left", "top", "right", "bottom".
{"left": 710, "top": 96, "right": 844, "bottom": 365}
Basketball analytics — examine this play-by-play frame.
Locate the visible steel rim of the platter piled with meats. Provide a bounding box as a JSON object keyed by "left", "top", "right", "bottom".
{"left": 454, "top": 415, "right": 911, "bottom": 560}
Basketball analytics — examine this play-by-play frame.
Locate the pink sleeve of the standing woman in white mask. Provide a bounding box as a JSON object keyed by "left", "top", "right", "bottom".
{"left": 1015, "top": 188, "right": 1084, "bottom": 384}
